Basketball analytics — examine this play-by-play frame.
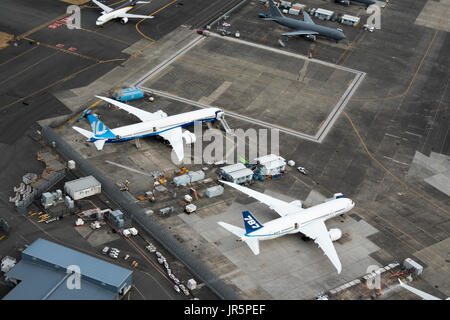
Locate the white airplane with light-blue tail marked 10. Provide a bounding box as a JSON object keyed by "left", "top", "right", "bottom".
{"left": 72, "top": 96, "right": 229, "bottom": 161}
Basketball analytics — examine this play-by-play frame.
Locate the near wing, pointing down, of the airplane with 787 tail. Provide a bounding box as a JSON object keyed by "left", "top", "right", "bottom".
{"left": 300, "top": 220, "right": 342, "bottom": 273}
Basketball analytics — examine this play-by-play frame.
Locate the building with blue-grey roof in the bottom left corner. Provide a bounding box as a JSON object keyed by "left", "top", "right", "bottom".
{"left": 3, "top": 239, "right": 133, "bottom": 300}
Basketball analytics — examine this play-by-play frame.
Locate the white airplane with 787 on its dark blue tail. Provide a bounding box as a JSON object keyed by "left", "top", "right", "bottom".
{"left": 218, "top": 181, "right": 355, "bottom": 273}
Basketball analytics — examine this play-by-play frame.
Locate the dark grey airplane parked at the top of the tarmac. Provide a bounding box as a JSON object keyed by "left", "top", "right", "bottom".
{"left": 260, "top": 0, "right": 345, "bottom": 42}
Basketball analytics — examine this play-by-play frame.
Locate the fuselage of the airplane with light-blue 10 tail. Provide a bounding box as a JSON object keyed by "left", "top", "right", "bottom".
{"left": 90, "top": 108, "right": 223, "bottom": 143}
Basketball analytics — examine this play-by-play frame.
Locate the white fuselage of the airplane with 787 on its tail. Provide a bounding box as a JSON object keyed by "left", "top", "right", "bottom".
{"left": 240, "top": 198, "right": 355, "bottom": 240}
